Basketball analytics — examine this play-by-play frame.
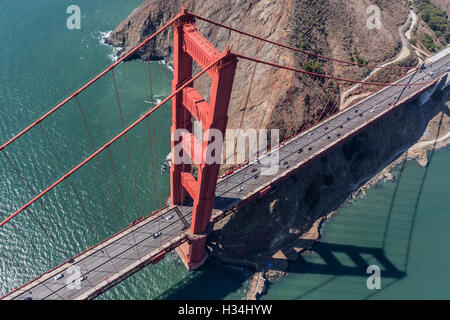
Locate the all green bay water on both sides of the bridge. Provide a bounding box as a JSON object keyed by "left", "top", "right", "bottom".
{"left": 0, "top": 0, "right": 450, "bottom": 299}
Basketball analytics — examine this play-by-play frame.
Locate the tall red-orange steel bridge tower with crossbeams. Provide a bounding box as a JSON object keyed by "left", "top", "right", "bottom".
{"left": 170, "top": 7, "right": 237, "bottom": 270}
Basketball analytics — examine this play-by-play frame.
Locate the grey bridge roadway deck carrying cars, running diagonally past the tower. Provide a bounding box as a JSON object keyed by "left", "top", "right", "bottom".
{"left": 3, "top": 48, "right": 450, "bottom": 300}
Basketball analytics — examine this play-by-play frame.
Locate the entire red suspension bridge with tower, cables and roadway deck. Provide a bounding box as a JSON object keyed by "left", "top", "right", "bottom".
{"left": 0, "top": 7, "right": 449, "bottom": 299}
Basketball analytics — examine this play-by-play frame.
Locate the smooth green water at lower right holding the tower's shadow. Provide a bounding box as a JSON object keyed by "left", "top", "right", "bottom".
{"left": 263, "top": 148, "right": 450, "bottom": 299}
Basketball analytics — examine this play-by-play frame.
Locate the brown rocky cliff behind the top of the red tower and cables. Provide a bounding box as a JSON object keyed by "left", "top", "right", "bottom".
{"left": 108, "top": 0, "right": 414, "bottom": 138}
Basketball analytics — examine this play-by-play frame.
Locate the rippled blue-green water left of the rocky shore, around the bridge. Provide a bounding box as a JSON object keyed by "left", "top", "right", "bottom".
{"left": 0, "top": 0, "right": 250, "bottom": 299}
